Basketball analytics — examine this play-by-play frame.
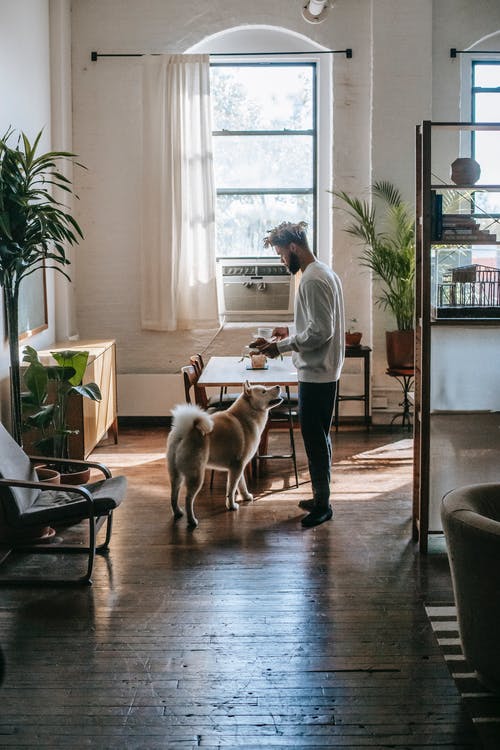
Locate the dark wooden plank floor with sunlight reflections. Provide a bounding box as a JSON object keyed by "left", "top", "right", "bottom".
{"left": 0, "top": 427, "right": 481, "bottom": 750}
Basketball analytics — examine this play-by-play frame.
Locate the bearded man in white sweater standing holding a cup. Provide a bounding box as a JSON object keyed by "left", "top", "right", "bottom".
{"left": 251, "top": 221, "right": 345, "bottom": 527}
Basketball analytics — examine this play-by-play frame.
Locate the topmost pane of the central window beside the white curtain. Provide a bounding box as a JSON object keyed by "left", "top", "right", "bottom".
{"left": 210, "top": 65, "right": 313, "bottom": 130}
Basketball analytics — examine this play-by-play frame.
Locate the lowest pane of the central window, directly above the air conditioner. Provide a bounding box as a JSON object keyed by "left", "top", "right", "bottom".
{"left": 216, "top": 195, "right": 313, "bottom": 258}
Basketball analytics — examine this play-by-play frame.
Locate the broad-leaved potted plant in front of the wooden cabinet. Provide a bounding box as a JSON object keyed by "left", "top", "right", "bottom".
{"left": 21, "top": 346, "right": 102, "bottom": 482}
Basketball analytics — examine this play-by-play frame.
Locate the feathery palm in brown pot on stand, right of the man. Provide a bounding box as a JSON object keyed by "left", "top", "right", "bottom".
{"left": 331, "top": 181, "right": 415, "bottom": 369}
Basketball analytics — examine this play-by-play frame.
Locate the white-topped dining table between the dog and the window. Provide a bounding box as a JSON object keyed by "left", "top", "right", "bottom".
{"left": 198, "top": 355, "right": 299, "bottom": 487}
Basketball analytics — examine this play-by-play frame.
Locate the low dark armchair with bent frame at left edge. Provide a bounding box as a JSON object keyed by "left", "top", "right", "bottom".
{"left": 0, "top": 424, "right": 127, "bottom": 585}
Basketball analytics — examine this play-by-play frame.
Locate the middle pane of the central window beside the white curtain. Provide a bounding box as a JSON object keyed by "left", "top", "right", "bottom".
{"left": 213, "top": 135, "right": 313, "bottom": 189}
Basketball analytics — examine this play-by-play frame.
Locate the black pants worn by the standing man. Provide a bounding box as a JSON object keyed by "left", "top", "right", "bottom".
{"left": 299, "top": 381, "right": 337, "bottom": 508}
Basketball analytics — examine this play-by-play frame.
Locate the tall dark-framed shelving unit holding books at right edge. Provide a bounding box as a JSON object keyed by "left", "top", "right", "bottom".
{"left": 412, "top": 121, "right": 500, "bottom": 552}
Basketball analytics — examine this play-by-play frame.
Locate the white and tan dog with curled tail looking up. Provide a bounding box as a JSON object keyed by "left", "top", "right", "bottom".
{"left": 167, "top": 382, "right": 282, "bottom": 526}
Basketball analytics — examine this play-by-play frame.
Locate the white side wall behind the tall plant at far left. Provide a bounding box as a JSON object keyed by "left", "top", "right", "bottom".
{"left": 0, "top": 0, "right": 54, "bottom": 421}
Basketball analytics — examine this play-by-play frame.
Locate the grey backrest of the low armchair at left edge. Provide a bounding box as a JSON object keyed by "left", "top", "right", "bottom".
{"left": 0, "top": 423, "right": 40, "bottom": 523}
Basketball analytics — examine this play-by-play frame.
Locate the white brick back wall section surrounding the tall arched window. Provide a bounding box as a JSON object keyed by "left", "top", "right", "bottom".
{"left": 72, "top": 0, "right": 370, "bottom": 418}
